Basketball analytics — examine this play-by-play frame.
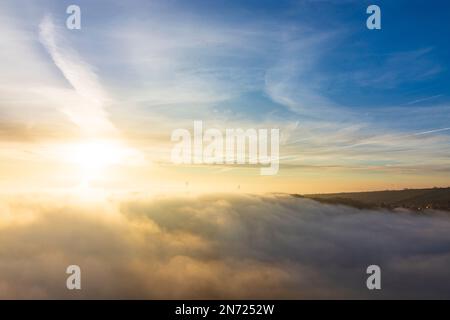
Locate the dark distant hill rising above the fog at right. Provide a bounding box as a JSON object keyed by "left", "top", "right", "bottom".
{"left": 293, "top": 188, "right": 450, "bottom": 211}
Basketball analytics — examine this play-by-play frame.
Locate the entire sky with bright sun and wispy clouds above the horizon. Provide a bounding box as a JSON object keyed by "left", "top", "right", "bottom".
{"left": 0, "top": 0, "right": 450, "bottom": 194}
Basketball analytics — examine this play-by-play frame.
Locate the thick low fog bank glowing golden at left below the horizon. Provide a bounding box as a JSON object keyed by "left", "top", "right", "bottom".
{"left": 0, "top": 195, "right": 450, "bottom": 298}
